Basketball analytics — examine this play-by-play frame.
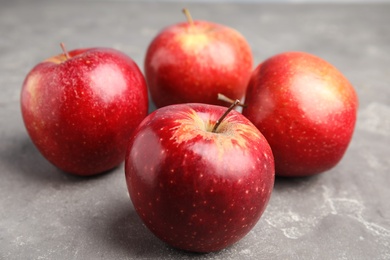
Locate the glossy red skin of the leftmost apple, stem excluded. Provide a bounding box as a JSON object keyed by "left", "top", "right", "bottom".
{"left": 21, "top": 48, "right": 148, "bottom": 176}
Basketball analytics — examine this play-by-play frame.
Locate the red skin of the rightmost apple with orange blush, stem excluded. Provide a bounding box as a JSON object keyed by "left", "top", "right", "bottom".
{"left": 243, "top": 52, "right": 358, "bottom": 177}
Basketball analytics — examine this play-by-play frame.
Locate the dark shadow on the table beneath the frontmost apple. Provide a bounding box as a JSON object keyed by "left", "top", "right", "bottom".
{"left": 90, "top": 202, "right": 204, "bottom": 259}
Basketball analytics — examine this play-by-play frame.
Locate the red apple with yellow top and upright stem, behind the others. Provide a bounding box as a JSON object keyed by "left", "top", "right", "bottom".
{"left": 144, "top": 9, "right": 253, "bottom": 107}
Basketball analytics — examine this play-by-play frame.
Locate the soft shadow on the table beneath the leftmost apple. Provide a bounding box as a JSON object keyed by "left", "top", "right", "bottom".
{"left": 0, "top": 136, "right": 114, "bottom": 184}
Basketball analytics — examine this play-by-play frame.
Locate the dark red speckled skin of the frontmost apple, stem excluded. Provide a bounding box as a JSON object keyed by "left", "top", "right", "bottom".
{"left": 125, "top": 104, "right": 275, "bottom": 252}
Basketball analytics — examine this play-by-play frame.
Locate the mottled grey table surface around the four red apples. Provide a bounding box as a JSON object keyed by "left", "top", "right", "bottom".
{"left": 0, "top": 0, "right": 390, "bottom": 259}
